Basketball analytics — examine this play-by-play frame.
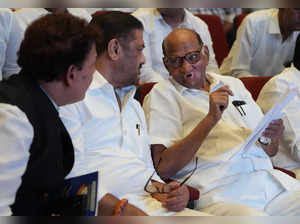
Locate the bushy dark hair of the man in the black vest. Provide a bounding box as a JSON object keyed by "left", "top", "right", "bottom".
{"left": 18, "top": 13, "right": 96, "bottom": 82}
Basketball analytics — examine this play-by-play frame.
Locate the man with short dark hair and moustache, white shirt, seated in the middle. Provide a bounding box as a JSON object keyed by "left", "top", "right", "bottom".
{"left": 60, "top": 12, "right": 206, "bottom": 216}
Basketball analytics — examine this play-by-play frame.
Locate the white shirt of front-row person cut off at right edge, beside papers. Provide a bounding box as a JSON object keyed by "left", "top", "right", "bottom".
{"left": 257, "top": 66, "right": 300, "bottom": 169}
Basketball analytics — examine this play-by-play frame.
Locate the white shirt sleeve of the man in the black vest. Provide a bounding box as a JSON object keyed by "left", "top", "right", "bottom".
{"left": 0, "top": 103, "right": 33, "bottom": 216}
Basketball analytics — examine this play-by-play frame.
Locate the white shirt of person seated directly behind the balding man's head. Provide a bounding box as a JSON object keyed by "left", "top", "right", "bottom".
{"left": 132, "top": 8, "right": 219, "bottom": 83}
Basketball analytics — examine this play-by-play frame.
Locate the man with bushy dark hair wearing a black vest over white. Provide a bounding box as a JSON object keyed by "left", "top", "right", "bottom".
{"left": 0, "top": 13, "right": 96, "bottom": 216}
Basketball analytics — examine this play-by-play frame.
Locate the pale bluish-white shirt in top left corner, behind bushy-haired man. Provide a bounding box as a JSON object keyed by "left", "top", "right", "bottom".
{"left": 0, "top": 8, "right": 22, "bottom": 80}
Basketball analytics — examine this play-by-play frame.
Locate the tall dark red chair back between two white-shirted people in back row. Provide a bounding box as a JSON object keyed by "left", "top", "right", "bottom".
{"left": 195, "top": 14, "right": 229, "bottom": 66}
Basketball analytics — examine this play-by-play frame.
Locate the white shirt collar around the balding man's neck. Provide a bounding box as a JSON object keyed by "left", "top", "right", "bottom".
{"left": 169, "top": 72, "right": 223, "bottom": 95}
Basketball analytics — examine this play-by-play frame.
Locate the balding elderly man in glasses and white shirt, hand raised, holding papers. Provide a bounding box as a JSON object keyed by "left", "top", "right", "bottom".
{"left": 144, "top": 29, "right": 300, "bottom": 215}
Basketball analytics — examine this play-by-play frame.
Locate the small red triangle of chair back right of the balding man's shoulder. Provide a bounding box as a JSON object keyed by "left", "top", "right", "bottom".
{"left": 240, "top": 76, "right": 273, "bottom": 101}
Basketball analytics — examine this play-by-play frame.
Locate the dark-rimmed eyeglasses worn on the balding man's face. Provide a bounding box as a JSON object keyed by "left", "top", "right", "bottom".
{"left": 164, "top": 46, "right": 204, "bottom": 68}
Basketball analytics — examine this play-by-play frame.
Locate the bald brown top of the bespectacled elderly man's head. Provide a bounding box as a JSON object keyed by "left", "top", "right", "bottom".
{"left": 162, "top": 29, "right": 203, "bottom": 56}
